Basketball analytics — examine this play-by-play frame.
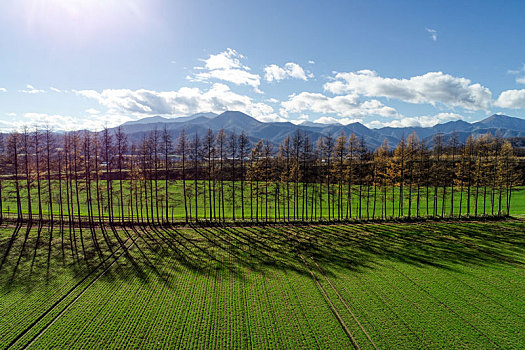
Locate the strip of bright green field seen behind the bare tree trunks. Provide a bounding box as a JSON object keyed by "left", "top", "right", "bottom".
{"left": 2, "top": 180, "right": 525, "bottom": 222}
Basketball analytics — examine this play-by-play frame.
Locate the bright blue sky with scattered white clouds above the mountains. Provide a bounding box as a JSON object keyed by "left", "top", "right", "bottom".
{"left": 0, "top": 0, "right": 525, "bottom": 130}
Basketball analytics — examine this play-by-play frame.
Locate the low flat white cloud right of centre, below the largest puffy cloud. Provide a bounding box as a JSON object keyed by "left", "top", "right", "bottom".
{"left": 281, "top": 92, "right": 398, "bottom": 118}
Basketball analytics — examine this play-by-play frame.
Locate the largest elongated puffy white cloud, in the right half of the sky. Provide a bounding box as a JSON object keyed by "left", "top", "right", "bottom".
{"left": 323, "top": 70, "right": 492, "bottom": 110}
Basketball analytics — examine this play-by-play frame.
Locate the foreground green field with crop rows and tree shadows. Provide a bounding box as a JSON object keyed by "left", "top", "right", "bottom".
{"left": 0, "top": 220, "right": 525, "bottom": 349}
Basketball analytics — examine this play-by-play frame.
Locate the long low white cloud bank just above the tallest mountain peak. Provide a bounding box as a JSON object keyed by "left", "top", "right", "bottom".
{"left": 75, "top": 83, "right": 282, "bottom": 121}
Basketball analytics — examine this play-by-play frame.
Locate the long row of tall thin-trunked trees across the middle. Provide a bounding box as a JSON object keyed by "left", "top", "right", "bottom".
{"left": 0, "top": 128, "right": 521, "bottom": 225}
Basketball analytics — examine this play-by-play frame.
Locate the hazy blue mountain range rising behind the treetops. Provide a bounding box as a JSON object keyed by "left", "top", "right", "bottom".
{"left": 112, "top": 111, "right": 525, "bottom": 149}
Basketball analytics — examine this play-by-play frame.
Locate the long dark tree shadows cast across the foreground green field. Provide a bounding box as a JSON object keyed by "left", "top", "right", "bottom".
{"left": 0, "top": 220, "right": 525, "bottom": 292}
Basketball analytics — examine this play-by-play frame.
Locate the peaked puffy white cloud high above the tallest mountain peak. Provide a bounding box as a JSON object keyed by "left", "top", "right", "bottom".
{"left": 186, "top": 48, "right": 261, "bottom": 93}
